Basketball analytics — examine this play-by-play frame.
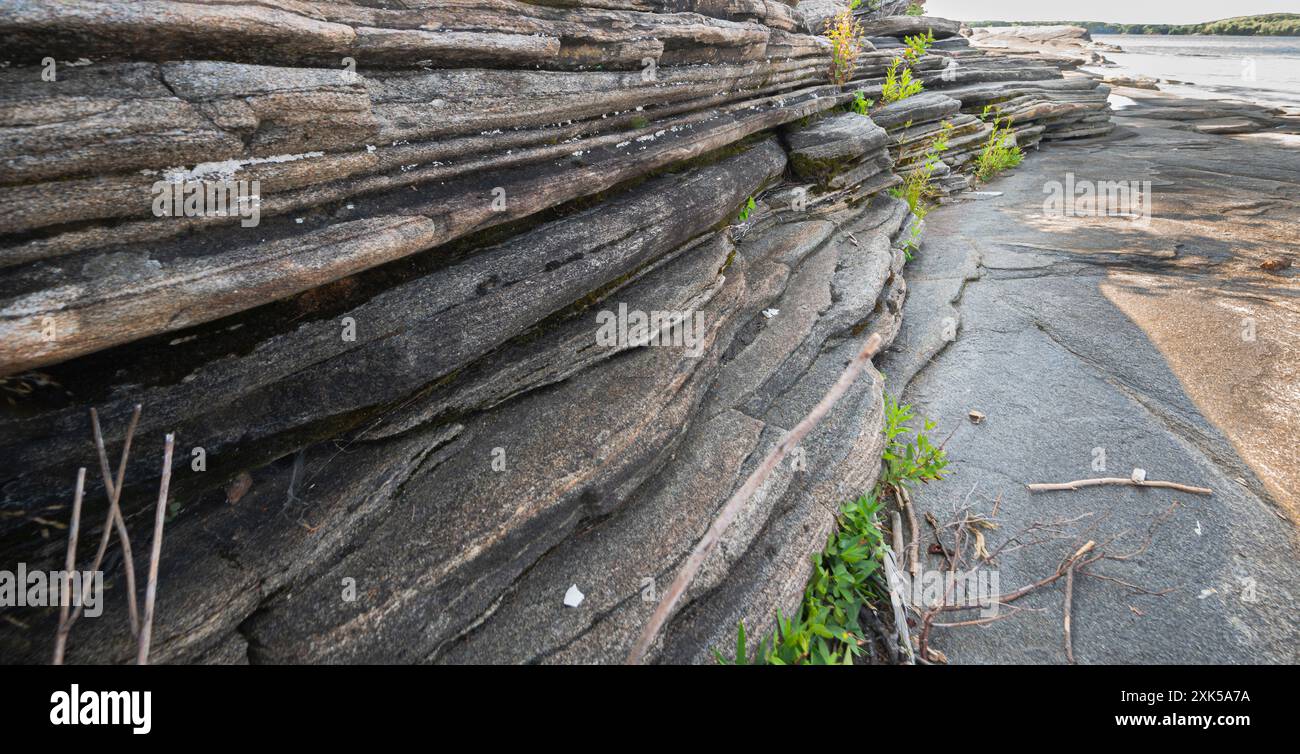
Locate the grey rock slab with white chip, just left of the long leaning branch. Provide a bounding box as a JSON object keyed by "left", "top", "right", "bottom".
{"left": 437, "top": 411, "right": 789, "bottom": 663}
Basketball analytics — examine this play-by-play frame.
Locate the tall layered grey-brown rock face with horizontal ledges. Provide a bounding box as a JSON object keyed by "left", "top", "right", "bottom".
{"left": 0, "top": 0, "right": 1104, "bottom": 663}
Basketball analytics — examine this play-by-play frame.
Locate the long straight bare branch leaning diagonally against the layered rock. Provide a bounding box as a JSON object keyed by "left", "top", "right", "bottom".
{"left": 627, "top": 333, "right": 883, "bottom": 664}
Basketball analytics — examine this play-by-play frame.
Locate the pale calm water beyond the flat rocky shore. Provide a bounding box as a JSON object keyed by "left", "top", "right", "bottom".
{"left": 1093, "top": 34, "right": 1300, "bottom": 109}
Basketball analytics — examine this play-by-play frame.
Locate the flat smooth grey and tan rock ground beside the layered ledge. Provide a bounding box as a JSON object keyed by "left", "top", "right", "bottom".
{"left": 879, "top": 98, "right": 1300, "bottom": 663}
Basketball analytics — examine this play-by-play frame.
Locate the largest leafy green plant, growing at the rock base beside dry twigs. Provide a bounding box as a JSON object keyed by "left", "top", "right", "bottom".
{"left": 714, "top": 395, "right": 948, "bottom": 664}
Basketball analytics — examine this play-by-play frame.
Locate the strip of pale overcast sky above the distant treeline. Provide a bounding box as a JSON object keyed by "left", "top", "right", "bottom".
{"left": 926, "top": 0, "right": 1300, "bottom": 23}
